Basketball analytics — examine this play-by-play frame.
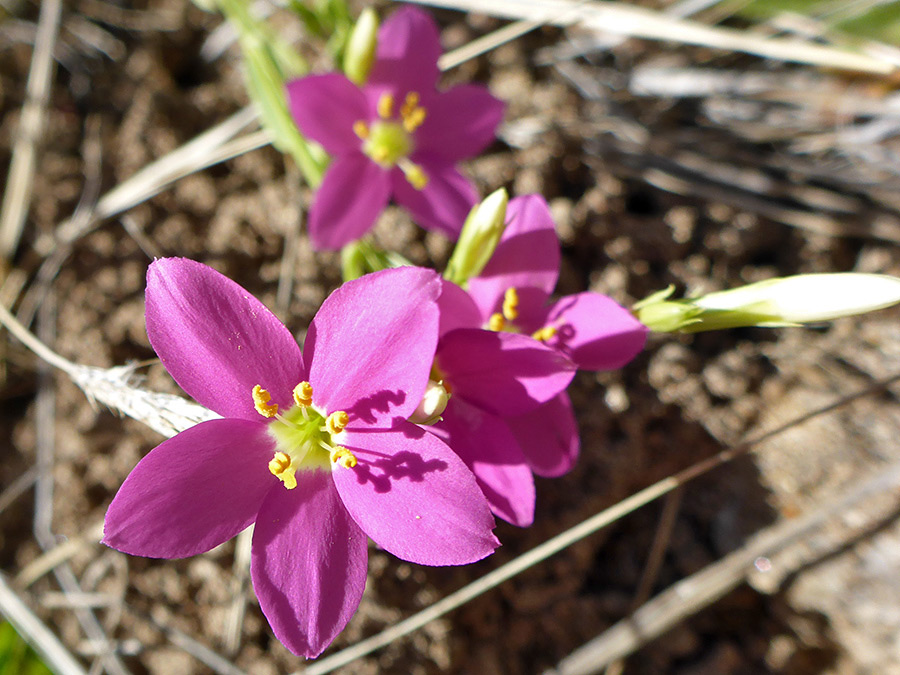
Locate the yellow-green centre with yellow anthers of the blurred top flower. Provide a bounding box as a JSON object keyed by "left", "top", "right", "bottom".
{"left": 353, "top": 91, "right": 428, "bottom": 190}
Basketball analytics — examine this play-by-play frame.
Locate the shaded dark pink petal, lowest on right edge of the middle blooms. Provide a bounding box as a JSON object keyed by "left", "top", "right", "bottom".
{"left": 506, "top": 393, "right": 581, "bottom": 478}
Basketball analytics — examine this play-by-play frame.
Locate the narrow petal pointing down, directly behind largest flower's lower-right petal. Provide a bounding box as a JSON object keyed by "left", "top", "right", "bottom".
{"left": 429, "top": 398, "right": 535, "bottom": 527}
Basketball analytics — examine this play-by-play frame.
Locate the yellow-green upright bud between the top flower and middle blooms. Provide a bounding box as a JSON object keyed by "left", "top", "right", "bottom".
{"left": 444, "top": 188, "right": 509, "bottom": 288}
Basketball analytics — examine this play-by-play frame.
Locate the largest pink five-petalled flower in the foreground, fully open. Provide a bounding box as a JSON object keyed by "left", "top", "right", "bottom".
{"left": 103, "top": 258, "right": 497, "bottom": 657}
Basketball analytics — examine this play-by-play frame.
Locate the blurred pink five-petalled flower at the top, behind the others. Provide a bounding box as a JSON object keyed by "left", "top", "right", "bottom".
{"left": 287, "top": 7, "right": 503, "bottom": 249}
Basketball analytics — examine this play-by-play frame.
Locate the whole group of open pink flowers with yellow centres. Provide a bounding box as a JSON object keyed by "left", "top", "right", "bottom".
{"left": 103, "top": 1, "right": 647, "bottom": 658}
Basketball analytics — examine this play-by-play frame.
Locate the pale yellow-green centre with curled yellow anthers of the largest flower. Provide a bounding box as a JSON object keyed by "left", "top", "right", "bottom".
{"left": 251, "top": 382, "right": 356, "bottom": 490}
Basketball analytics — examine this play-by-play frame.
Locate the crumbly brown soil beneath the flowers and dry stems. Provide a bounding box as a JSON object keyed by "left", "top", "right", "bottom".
{"left": 0, "top": 0, "right": 900, "bottom": 675}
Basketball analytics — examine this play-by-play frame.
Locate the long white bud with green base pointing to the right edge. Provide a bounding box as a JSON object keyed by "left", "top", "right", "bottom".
{"left": 636, "top": 273, "right": 900, "bottom": 333}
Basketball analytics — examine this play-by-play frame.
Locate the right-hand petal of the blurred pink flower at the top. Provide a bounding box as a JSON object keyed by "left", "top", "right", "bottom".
{"left": 415, "top": 84, "right": 504, "bottom": 163}
